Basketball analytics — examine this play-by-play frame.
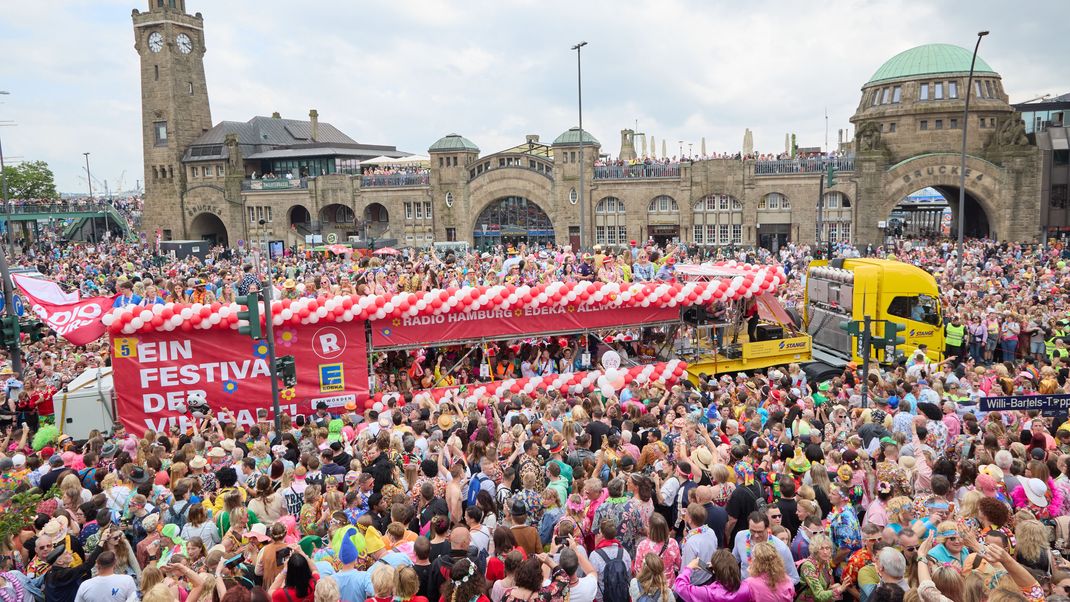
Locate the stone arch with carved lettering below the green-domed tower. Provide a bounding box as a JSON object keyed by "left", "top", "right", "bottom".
{"left": 873, "top": 153, "right": 1009, "bottom": 235}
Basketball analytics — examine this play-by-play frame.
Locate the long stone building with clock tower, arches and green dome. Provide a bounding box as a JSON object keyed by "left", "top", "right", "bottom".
{"left": 133, "top": 0, "right": 1044, "bottom": 249}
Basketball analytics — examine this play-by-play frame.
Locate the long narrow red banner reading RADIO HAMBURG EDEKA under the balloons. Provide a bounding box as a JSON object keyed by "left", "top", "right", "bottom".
{"left": 371, "top": 305, "right": 679, "bottom": 349}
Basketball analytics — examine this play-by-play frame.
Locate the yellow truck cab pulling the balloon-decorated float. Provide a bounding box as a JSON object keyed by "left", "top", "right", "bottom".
{"left": 803, "top": 259, "right": 944, "bottom": 366}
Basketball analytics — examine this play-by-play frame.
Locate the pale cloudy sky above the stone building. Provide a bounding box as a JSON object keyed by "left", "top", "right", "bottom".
{"left": 0, "top": 0, "right": 1070, "bottom": 191}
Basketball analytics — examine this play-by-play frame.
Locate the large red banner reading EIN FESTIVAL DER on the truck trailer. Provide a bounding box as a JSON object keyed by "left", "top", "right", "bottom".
{"left": 111, "top": 321, "right": 368, "bottom": 435}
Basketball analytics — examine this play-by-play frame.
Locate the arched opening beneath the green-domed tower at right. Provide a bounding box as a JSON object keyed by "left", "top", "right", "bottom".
{"left": 885, "top": 186, "right": 991, "bottom": 240}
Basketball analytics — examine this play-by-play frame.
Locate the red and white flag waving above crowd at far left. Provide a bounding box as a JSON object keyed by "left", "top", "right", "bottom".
{"left": 13, "top": 276, "right": 116, "bottom": 345}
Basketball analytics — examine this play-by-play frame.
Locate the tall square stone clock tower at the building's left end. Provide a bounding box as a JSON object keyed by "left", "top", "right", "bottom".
{"left": 132, "top": 0, "right": 212, "bottom": 242}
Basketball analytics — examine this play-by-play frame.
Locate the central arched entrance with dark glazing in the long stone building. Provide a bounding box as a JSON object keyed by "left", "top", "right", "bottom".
{"left": 472, "top": 197, "right": 554, "bottom": 249}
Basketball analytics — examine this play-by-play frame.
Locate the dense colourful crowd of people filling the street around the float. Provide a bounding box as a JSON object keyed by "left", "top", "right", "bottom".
{"left": 0, "top": 227, "right": 1070, "bottom": 602}
